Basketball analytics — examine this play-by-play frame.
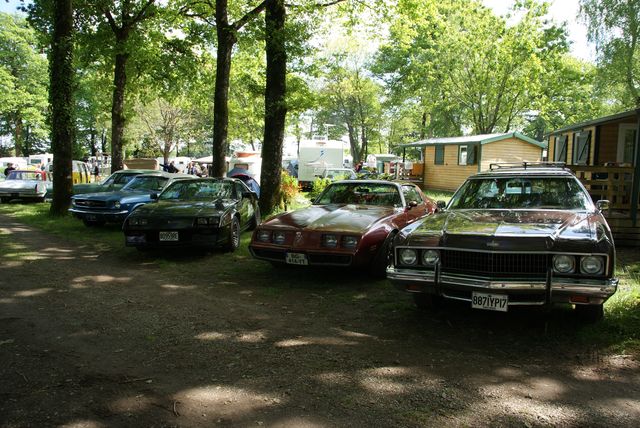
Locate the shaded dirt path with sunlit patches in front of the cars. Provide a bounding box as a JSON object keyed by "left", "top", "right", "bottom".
{"left": 0, "top": 216, "right": 640, "bottom": 427}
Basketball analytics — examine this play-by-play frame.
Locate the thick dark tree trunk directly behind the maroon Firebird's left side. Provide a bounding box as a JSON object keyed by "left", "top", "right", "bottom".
{"left": 260, "top": 0, "right": 287, "bottom": 214}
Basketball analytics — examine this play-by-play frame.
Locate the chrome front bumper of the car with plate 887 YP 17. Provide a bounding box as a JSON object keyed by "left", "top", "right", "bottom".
{"left": 387, "top": 267, "right": 618, "bottom": 306}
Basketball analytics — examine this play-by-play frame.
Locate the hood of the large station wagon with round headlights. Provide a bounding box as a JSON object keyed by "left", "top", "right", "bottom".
{"left": 403, "top": 210, "right": 610, "bottom": 251}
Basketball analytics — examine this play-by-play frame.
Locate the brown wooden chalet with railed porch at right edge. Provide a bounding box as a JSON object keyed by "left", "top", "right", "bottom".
{"left": 548, "top": 110, "right": 640, "bottom": 246}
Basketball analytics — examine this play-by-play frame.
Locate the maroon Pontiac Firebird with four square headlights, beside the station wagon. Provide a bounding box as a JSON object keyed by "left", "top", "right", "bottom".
{"left": 249, "top": 180, "right": 436, "bottom": 276}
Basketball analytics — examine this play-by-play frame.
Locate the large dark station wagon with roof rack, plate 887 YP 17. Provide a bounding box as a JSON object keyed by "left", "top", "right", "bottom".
{"left": 387, "top": 164, "right": 618, "bottom": 320}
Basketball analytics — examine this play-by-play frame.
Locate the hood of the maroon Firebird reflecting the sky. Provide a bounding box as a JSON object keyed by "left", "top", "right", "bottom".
{"left": 265, "top": 205, "right": 396, "bottom": 233}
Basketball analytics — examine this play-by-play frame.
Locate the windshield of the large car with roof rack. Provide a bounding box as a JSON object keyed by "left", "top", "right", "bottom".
{"left": 449, "top": 177, "right": 591, "bottom": 210}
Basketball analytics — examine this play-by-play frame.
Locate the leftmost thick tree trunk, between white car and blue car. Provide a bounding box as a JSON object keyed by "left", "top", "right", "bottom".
{"left": 49, "top": 0, "right": 75, "bottom": 215}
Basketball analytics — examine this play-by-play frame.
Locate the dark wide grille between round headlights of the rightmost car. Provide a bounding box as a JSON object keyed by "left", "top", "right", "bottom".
{"left": 441, "top": 250, "right": 549, "bottom": 276}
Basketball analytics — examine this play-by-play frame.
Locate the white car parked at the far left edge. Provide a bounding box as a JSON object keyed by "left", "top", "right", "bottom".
{"left": 0, "top": 169, "right": 53, "bottom": 204}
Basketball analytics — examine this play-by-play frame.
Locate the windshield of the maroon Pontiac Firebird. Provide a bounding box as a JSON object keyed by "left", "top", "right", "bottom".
{"left": 315, "top": 183, "right": 402, "bottom": 207}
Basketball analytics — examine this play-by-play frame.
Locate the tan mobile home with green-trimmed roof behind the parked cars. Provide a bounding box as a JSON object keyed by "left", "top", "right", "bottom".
{"left": 401, "top": 132, "right": 546, "bottom": 191}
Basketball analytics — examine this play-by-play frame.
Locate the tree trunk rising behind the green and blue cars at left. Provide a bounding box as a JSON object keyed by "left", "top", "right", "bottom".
{"left": 111, "top": 36, "right": 129, "bottom": 172}
